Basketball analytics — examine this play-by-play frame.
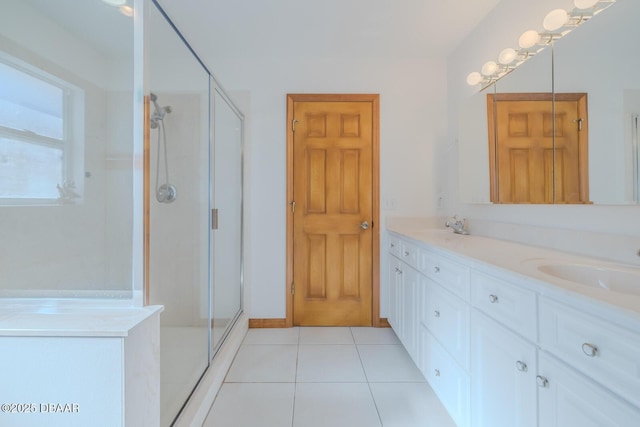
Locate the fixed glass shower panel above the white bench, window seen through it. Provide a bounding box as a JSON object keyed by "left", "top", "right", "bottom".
{"left": 0, "top": 0, "right": 134, "bottom": 298}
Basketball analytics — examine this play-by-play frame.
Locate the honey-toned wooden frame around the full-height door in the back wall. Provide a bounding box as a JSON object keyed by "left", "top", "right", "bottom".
{"left": 285, "top": 93, "right": 381, "bottom": 328}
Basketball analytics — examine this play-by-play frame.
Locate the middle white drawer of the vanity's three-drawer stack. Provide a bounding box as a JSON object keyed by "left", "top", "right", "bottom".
{"left": 420, "top": 279, "right": 469, "bottom": 370}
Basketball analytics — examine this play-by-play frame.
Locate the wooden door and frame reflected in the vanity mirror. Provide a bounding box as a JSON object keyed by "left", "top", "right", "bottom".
{"left": 487, "top": 93, "right": 590, "bottom": 204}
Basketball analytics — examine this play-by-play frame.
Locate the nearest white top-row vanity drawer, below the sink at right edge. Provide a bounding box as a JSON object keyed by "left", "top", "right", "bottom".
{"left": 539, "top": 297, "right": 640, "bottom": 406}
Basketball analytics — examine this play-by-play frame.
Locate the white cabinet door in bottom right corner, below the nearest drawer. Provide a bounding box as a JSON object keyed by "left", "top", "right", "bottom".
{"left": 538, "top": 352, "right": 640, "bottom": 427}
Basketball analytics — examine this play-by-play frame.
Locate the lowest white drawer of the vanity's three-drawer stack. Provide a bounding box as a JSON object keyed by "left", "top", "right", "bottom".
{"left": 420, "top": 326, "right": 471, "bottom": 427}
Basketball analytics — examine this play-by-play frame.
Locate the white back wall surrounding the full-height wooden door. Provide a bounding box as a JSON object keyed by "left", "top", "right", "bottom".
{"left": 203, "top": 56, "right": 446, "bottom": 318}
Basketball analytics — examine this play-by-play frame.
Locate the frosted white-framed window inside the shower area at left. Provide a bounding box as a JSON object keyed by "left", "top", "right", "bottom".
{"left": 0, "top": 56, "right": 84, "bottom": 205}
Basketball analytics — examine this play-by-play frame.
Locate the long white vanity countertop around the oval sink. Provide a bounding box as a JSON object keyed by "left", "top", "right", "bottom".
{"left": 387, "top": 221, "right": 640, "bottom": 331}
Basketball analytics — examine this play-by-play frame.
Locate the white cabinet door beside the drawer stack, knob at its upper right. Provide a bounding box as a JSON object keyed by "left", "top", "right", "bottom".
{"left": 471, "top": 310, "right": 537, "bottom": 427}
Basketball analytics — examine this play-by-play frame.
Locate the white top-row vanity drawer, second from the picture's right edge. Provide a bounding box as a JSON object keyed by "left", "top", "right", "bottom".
{"left": 471, "top": 271, "right": 537, "bottom": 342}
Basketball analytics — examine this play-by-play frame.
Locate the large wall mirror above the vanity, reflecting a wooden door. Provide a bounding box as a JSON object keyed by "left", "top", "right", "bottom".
{"left": 459, "top": 0, "right": 640, "bottom": 204}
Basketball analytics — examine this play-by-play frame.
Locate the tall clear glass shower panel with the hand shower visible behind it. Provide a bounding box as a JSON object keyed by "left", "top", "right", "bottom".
{"left": 146, "top": 5, "right": 211, "bottom": 427}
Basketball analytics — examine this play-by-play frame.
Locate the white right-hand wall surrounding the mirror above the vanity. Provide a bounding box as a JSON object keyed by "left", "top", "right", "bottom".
{"left": 439, "top": 0, "right": 640, "bottom": 263}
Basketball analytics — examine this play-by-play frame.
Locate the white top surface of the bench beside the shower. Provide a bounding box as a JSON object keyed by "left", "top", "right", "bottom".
{"left": 0, "top": 298, "right": 163, "bottom": 337}
